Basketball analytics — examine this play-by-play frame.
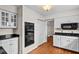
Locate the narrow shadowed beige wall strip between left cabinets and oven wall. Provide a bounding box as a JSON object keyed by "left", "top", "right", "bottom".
{"left": 13, "top": 6, "right": 23, "bottom": 53}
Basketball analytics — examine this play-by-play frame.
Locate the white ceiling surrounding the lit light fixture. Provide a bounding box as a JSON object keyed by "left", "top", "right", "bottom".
{"left": 26, "top": 5, "right": 79, "bottom": 16}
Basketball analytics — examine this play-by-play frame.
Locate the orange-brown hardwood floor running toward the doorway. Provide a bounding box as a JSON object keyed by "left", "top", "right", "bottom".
{"left": 30, "top": 37, "right": 78, "bottom": 54}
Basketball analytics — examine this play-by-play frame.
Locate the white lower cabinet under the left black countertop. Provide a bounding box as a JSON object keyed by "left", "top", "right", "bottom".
{"left": 2, "top": 37, "right": 18, "bottom": 54}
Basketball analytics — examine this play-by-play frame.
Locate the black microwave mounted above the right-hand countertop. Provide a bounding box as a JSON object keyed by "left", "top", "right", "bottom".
{"left": 61, "top": 23, "right": 78, "bottom": 30}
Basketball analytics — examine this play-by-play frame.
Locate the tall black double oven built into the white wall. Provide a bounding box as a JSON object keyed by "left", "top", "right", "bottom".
{"left": 25, "top": 22, "right": 34, "bottom": 47}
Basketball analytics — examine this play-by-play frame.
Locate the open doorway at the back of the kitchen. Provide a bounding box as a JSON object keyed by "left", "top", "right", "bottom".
{"left": 47, "top": 20, "right": 54, "bottom": 44}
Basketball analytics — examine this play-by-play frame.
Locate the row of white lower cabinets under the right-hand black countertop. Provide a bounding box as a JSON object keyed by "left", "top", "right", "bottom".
{"left": 53, "top": 35, "right": 79, "bottom": 52}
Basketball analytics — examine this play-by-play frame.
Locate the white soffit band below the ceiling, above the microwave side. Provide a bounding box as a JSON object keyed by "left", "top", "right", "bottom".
{"left": 47, "top": 9, "right": 79, "bottom": 19}
